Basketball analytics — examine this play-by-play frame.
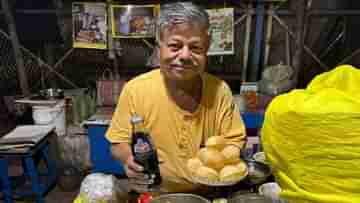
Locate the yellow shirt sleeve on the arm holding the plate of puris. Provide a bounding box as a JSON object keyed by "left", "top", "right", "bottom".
{"left": 219, "top": 83, "right": 246, "bottom": 148}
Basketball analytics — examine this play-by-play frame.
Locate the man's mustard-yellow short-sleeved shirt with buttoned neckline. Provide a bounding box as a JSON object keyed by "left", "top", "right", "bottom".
{"left": 106, "top": 69, "right": 245, "bottom": 192}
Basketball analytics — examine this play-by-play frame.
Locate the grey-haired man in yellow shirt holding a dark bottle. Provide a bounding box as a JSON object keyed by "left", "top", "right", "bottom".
{"left": 106, "top": 3, "right": 245, "bottom": 195}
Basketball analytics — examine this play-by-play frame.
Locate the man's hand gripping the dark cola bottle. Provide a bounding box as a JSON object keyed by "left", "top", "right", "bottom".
{"left": 124, "top": 155, "right": 154, "bottom": 193}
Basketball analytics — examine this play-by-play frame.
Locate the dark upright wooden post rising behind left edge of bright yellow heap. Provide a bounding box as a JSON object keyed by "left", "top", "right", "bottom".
{"left": 293, "top": 0, "right": 307, "bottom": 87}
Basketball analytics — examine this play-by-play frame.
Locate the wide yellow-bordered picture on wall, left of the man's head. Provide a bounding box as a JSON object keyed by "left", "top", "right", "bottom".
{"left": 111, "top": 5, "right": 155, "bottom": 38}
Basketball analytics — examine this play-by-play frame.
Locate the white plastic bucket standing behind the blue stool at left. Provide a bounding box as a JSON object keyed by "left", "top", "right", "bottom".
{"left": 32, "top": 101, "right": 66, "bottom": 136}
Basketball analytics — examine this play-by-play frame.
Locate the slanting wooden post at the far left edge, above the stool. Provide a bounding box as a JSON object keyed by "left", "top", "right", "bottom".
{"left": 1, "top": 0, "right": 30, "bottom": 95}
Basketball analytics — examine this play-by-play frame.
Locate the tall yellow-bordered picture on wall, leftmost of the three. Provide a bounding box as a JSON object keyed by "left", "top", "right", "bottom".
{"left": 72, "top": 2, "right": 107, "bottom": 49}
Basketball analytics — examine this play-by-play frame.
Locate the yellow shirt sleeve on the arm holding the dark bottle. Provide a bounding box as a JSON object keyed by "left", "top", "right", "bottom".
{"left": 106, "top": 84, "right": 134, "bottom": 143}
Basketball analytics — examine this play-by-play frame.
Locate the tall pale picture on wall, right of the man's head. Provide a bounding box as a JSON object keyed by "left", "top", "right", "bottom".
{"left": 207, "top": 8, "right": 234, "bottom": 55}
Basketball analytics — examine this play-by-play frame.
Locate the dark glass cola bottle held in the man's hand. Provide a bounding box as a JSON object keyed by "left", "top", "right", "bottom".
{"left": 130, "top": 115, "right": 161, "bottom": 188}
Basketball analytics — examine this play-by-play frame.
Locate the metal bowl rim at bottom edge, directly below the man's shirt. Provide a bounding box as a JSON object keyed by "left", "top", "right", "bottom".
{"left": 150, "top": 193, "right": 211, "bottom": 203}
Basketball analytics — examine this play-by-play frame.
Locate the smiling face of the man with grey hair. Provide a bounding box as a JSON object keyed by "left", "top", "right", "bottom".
{"left": 160, "top": 23, "right": 210, "bottom": 81}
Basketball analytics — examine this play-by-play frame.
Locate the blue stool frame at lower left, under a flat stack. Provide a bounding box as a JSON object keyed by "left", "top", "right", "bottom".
{"left": 0, "top": 131, "right": 56, "bottom": 203}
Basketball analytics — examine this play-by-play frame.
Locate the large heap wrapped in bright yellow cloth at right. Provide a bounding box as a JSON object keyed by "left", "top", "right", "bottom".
{"left": 261, "top": 65, "right": 360, "bottom": 203}
